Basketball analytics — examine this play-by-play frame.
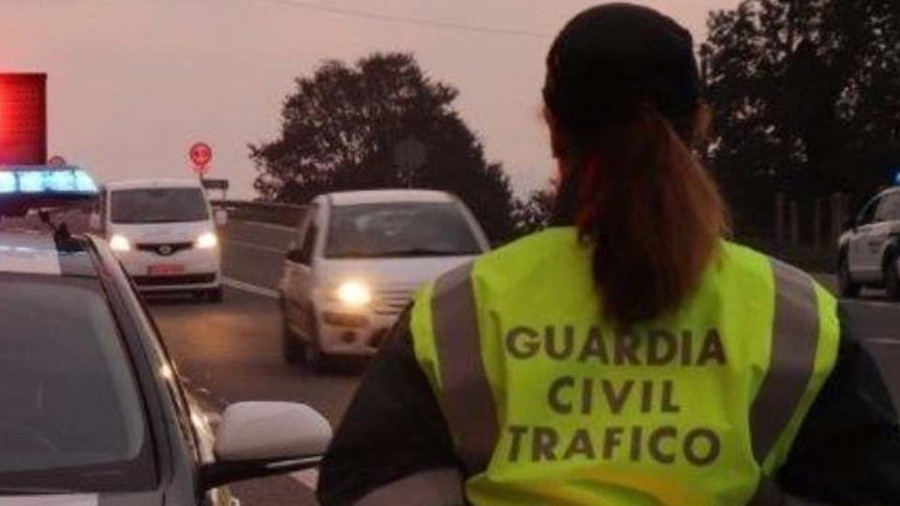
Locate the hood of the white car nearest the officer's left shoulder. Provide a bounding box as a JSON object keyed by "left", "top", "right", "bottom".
{"left": 315, "top": 256, "right": 475, "bottom": 289}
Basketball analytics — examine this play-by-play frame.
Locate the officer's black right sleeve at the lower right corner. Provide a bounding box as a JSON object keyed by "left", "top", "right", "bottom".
{"left": 778, "top": 302, "right": 900, "bottom": 505}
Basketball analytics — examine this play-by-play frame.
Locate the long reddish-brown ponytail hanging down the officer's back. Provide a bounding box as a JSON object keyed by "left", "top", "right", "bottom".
{"left": 563, "top": 106, "right": 728, "bottom": 328}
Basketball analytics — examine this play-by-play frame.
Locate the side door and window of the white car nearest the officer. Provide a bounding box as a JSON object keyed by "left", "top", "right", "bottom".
{"left": 284, "top": 208, "right": 320, "bottom": 336}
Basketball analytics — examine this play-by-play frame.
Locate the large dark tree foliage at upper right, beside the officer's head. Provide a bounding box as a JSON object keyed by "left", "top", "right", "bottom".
{"left": 701, "top": 0, "right": 900, "bottom": 237}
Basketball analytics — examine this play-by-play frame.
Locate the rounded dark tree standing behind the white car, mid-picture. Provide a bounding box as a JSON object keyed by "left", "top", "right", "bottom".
{"left": 250, "top": 53, "right": 514, "bottom": 241}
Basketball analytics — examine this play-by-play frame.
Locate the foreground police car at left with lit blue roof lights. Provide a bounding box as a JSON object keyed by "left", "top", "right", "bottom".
{"left": 0, "top": 167, "right": 331, "bottom": 506}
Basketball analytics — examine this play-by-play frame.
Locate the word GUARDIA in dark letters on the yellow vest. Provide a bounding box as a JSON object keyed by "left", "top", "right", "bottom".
{"left": 505, "top": 325, "right": 728, "bottom": 367}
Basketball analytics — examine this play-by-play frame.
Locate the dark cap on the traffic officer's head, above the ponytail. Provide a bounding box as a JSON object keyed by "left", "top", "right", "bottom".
{"left": 544, "top": 3, "right": 701, "bottom": 130}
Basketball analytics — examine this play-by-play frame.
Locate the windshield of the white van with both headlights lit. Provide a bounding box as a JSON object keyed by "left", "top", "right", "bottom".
{"left": 111, "top": 188, "right": 209, "bottom": 223}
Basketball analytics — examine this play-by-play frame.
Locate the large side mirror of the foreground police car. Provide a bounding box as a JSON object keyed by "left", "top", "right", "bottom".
{"left": 200, "top": 402, "right": 332, "bottom": 490}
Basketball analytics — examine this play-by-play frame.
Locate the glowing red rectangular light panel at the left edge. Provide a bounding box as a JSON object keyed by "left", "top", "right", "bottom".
{"left": 0, "top": 74, "right": 47, "bottom": 165}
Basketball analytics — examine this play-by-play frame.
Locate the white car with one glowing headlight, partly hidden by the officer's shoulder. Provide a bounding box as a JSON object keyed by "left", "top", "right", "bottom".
{"left": 279, "top": 190, "right": 489, "bottom": 370}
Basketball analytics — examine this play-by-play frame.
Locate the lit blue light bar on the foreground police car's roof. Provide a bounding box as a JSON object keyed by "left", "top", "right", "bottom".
{"left": 0, "top": 166, "right": 98, "bottom": 198}
